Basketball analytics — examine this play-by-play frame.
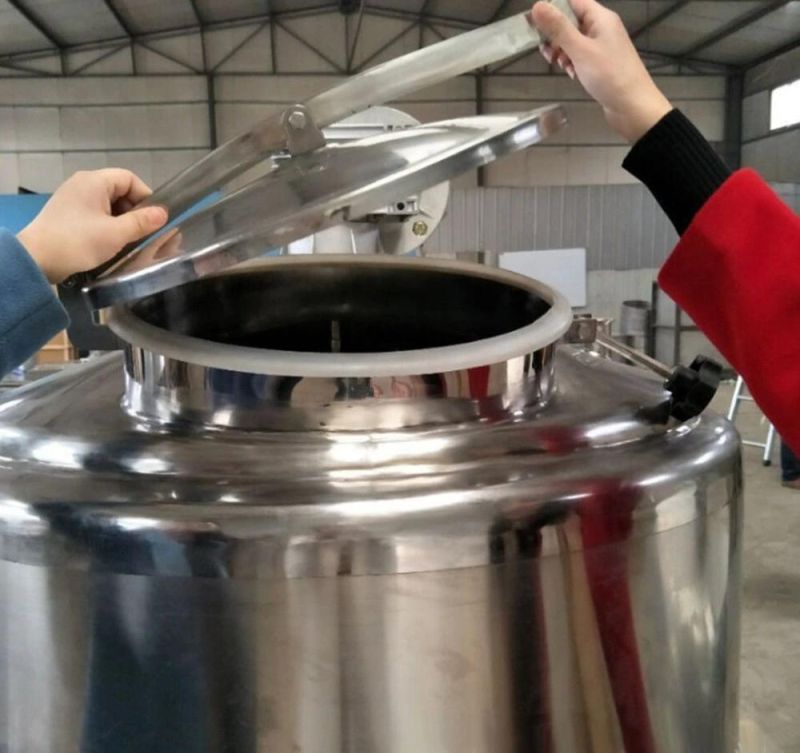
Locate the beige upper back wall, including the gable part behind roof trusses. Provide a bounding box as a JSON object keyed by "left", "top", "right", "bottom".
{"left": 0, "top": 13, "right": 725, "bottom": 192}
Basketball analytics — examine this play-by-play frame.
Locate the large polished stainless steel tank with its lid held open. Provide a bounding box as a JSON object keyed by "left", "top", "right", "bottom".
{"left": 0, "top": 11, "right": 741, "bottom": 753}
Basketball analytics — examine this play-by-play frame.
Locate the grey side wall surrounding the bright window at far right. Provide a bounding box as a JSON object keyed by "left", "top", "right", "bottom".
{"left": 742, "top": 49, "right": 800, "bottom": 184}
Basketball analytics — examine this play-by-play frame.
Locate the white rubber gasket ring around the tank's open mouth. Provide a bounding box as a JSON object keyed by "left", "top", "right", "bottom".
{"left": 108, "top": 256, "right": 572, "bottom": 377}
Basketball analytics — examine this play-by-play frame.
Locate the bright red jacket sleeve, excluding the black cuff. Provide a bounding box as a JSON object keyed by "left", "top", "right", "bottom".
{"left": 659, "top": 170, "right": 800, "bottom": 453}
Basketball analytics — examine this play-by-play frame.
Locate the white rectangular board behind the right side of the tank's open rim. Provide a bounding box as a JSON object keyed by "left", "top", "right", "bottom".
{"left": 500, "top": 248, "right": 586, "bottom": 308}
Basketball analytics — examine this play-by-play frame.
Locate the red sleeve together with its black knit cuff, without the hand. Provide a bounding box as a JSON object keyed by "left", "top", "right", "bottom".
{"left": 624, "top": 110, "right": 800, "bottom": 448}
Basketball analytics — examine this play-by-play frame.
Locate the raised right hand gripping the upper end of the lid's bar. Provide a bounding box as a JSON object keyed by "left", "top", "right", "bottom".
{"left": 532, "top": 0, "right": 672, "bottom": 143}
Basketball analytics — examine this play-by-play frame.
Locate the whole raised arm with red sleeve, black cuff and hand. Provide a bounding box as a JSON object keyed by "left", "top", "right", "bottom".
{"left": 533, "top": 0, "right": 800, "bottom": 449}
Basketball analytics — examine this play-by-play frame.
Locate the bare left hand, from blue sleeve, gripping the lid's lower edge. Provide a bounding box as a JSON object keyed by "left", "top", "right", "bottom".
{"left": 17, "top": 168, "right": 167, "bottom": 283}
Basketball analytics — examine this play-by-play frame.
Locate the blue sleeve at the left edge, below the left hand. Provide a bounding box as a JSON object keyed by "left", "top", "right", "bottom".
{"left": 0, "top": 230, "right": 69, "bottom": 376}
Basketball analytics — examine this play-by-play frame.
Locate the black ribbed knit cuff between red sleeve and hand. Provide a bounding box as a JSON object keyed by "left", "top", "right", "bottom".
{"left": 622, "top": 110, "right": 731, "bottom": 235}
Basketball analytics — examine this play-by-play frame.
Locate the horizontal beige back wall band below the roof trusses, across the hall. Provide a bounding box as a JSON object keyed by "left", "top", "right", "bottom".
{"left": 0, "top": 69, "right": 724, "bottom": 192}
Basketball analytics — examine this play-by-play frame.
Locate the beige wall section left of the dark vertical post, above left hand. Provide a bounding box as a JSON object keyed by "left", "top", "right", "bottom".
{"left": 0, "top": 76, "right": 209, "bottom": 193}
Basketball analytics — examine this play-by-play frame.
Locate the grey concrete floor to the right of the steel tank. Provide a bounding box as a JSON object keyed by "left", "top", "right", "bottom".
{"left": 713, "top": 385, "right": 800, "bottom": 753}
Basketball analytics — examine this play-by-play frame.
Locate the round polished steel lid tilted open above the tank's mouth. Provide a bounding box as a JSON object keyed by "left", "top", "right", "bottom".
{"left": 84, "top": 105, "right": 566, "bottom": 309}
